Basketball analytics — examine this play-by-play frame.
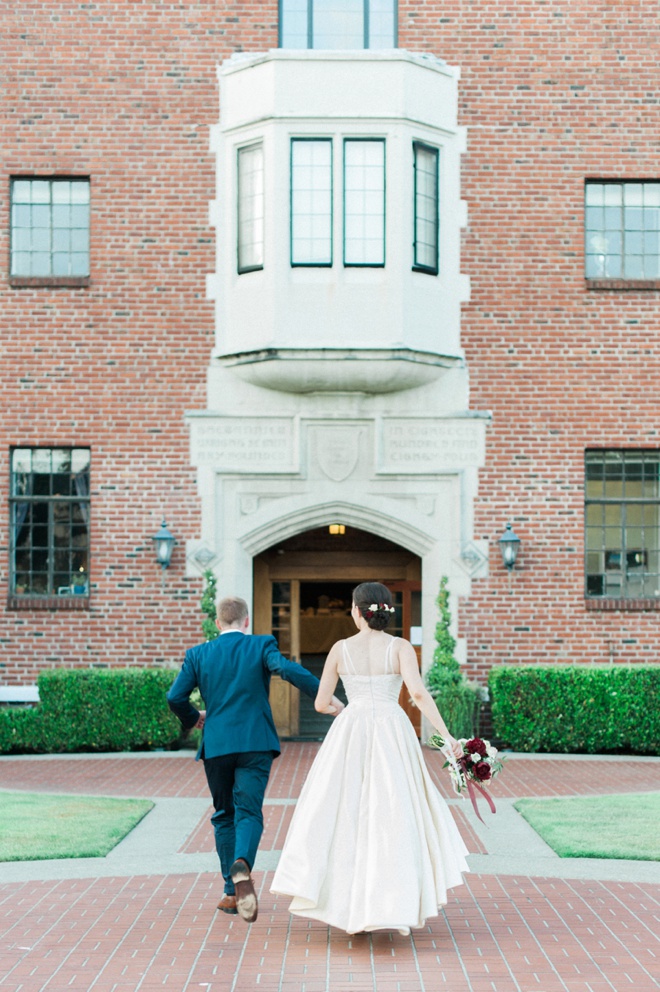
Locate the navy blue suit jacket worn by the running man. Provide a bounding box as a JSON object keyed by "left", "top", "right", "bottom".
{"left": 167, "top": 630, "right": 319, "bottom": 758}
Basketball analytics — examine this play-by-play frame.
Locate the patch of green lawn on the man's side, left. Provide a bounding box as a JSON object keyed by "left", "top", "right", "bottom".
{"left": 0, "top": 792, "right": 154, "bottom": 861}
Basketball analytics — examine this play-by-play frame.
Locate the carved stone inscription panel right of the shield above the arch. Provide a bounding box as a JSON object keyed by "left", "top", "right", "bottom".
{"left": 379, "top": 417, "right": 484, "bottom": 474}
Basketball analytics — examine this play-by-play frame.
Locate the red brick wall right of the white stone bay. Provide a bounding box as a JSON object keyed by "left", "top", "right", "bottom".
{"left": 399, "top": 0, "right": 660, "bottom": 677}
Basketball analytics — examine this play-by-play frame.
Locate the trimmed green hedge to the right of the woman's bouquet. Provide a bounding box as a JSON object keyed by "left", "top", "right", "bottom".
{"left": 489, "top": 665, "right": 660, "bottom": 754}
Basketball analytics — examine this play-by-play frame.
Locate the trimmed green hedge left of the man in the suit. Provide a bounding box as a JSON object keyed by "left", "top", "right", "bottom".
{"left": 0, "top": 669, "right": 181, "bottom": 754}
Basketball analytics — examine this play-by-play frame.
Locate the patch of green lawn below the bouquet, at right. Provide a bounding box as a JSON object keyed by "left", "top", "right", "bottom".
{"left": 514, "top": 792, "right": 660, "bottom": 861}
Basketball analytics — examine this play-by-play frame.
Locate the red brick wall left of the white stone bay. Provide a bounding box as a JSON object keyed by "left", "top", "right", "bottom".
{"left": 0, "top": 0, "right": 277, "bottom": 682}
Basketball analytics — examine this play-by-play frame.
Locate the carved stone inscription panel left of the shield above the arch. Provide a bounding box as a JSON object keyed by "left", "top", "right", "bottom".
{"left": 191, "top": 417, "right": 296, "bottom": 474}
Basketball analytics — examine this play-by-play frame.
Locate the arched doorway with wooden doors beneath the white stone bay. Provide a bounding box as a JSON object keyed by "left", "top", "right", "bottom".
{"left": 253, "top": 525, "right": 422, "bottom": 740}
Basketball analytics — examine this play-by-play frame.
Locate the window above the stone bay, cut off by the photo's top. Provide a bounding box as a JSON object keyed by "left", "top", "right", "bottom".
{"left": 280, "top": 0, "right": 397, "bottom": 49}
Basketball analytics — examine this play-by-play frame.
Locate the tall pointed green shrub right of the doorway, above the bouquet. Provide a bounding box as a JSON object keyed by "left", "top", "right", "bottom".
{"left": 426, "top": 575, "right": 481, "bottom": 737}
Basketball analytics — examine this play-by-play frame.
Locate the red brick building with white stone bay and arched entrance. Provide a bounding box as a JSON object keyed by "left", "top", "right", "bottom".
{"left": 0, "top": 0, "right": 660, "bottom": 733}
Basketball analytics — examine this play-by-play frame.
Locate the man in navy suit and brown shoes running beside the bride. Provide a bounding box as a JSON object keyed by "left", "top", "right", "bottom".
{"left": 167, "top": 596, "right": 343, "bottom": 923}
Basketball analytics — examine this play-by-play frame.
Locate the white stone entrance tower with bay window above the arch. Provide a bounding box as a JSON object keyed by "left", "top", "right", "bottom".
{"left": 188, "top": 50, "right": 488, "bottom": 720}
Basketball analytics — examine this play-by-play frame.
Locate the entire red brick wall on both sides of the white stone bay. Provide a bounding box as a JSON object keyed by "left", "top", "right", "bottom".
{"left": 0, "top": 0, "right": 659, "bottom": 681}
